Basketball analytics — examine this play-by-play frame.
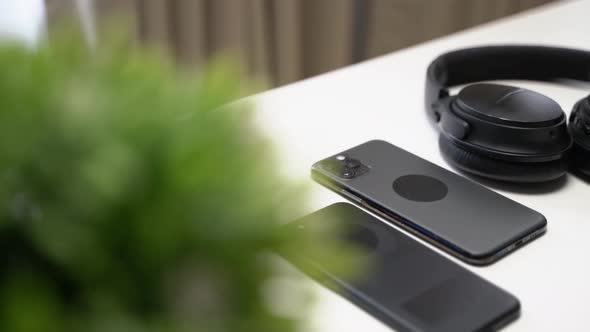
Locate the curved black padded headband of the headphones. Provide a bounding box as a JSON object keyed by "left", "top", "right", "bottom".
{"left": 424, "top": 46, "right": 590, "bottom": 118}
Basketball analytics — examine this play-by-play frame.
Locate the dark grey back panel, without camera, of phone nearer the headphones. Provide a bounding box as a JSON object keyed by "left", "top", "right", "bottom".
{"left": 313, "top": 140, "right": 546, "bottom": 257}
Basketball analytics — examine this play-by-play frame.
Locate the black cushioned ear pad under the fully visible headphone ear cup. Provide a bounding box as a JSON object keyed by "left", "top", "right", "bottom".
{"left": 438, "top": 135, "right": 567, "bottom": 183}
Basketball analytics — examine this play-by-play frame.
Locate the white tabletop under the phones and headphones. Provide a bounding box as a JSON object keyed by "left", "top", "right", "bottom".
{"left": 251, "top": 1, "right": 590, "bottom": 332}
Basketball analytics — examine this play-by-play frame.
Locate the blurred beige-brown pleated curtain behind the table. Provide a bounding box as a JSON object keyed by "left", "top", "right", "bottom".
{"left": 45, "top": 0, "right": 555, "bottom": 86}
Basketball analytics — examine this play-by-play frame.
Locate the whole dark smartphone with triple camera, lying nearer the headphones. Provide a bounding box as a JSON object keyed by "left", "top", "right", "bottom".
{"left": 312, "top": 140, "right": 547, "bottom": 265}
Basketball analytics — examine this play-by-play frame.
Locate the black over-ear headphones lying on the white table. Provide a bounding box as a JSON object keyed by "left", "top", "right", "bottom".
{"left": 425, "top": 46, "right": 590, "bottom": 182}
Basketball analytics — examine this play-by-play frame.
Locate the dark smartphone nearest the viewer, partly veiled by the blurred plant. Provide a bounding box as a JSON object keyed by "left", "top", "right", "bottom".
{"left": 286, "top": 203, "right": 520, "bottom": 332}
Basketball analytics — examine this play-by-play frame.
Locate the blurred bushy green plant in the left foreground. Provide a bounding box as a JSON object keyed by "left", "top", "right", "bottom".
{"left": 0, "top": 31, "right": 356, "bottom": 332}
